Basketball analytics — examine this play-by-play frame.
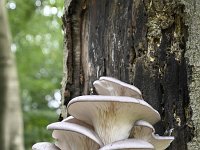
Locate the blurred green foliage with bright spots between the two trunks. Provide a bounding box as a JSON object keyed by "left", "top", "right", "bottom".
{"left": 6, "top": 0, "right": 64, "bottom": 150}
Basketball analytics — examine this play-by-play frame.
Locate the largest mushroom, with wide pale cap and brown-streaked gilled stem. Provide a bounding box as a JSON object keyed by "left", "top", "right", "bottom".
{"left": 68, "top": 95, "right": 160, "bottom": 144}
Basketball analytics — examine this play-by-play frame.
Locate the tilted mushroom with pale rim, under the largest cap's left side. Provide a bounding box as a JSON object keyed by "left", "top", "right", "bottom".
{"left": 47, "top": 117, "right": 103, "bottom": 150}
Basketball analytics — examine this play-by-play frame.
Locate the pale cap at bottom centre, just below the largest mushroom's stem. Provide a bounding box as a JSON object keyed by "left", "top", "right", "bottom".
{"left": 99, "top": 139, "right": 154, "bottom": 150}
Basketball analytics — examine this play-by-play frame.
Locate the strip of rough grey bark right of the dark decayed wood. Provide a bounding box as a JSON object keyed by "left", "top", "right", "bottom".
{"left": 182, "top": 0, "right": 200, "bottom": 150}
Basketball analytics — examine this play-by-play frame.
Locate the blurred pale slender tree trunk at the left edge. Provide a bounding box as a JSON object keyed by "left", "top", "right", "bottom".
{"left": 0, "top": 0, "right": 24, "bottom": 150}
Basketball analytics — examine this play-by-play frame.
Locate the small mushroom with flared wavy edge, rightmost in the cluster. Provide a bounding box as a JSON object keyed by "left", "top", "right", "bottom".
{"left": 130, "top": 120, "right": 174, "bottom": 150}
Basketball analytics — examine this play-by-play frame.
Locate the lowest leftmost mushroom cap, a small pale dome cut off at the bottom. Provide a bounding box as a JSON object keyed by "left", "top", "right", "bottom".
{"left": 32, "top": 142, "right": 60, "bottom": 150}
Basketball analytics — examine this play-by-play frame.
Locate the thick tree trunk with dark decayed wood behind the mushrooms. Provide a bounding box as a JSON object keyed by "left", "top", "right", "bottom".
{"left": 62, "top": 0, "right": 200, "bottom": 150}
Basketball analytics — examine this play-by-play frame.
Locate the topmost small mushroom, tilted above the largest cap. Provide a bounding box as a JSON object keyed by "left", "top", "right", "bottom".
{"left": 93, "top": 77, "right": 142, "bottom": 99}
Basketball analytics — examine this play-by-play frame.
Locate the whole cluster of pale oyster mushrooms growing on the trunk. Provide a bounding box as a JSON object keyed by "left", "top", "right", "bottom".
{"left": 32, "top": 77, "right": 174, "bottom": 150}
